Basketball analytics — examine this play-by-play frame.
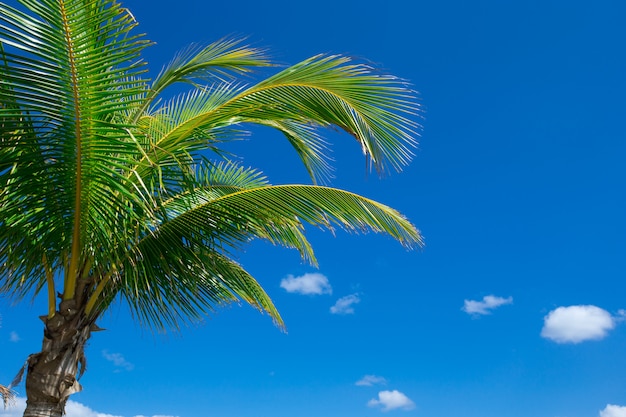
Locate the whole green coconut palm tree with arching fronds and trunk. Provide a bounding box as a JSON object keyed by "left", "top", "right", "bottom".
{"left": 0, "top": 0, "right": 421, "bottom": 417}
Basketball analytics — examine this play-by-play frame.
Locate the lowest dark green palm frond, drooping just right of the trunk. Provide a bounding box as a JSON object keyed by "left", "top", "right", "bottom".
{"left": 111, "top": 247, "right": 284, "bottom": 330}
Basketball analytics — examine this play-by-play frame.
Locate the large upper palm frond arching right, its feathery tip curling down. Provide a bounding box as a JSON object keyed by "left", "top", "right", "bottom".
{"left": 137, "top": 55, "right": 420, "bottom": 184}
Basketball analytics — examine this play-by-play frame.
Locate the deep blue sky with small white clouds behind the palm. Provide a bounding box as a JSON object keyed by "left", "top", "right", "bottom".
{"left": 0, "top": 0, "right": 626, "bottom": 417}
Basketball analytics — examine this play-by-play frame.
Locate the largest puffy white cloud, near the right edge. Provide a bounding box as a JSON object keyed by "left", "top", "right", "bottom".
{"left": 541, "top": 305, "right": 615, "bottom": 343}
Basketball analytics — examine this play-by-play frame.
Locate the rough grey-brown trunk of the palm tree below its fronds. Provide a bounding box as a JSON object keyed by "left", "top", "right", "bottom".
{"left": 24, "top": 301, "right": 92, "bottom": 417}
